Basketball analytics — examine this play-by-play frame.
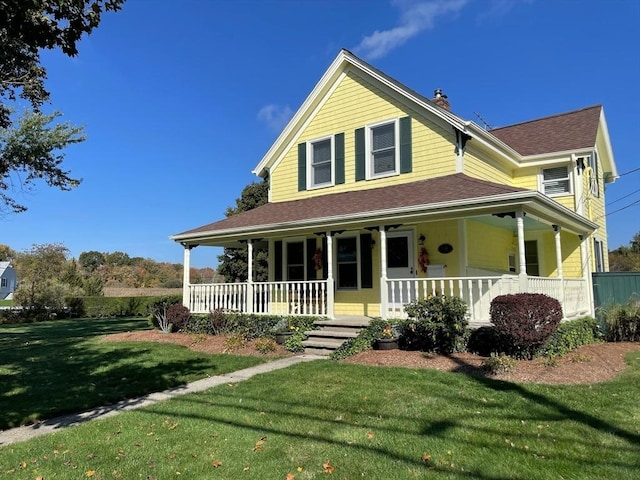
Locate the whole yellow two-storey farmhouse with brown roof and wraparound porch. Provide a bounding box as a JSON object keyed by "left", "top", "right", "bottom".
{"left": 171, "top": 50, "right": 617, "bottom": 330}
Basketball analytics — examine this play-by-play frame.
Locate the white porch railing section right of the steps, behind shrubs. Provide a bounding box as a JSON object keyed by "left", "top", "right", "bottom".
{"left": 383, "top": 275, "right": 589, "bottom": 324}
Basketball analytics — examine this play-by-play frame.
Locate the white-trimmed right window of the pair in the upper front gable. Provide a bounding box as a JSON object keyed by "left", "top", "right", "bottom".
{"left": 366, "top": 120, "right": 400, "bottom": 178}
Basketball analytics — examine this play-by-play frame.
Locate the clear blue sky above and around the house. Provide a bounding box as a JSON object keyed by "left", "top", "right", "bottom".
{"left": 0, "top": 0, "right": 640, "bottom": 267}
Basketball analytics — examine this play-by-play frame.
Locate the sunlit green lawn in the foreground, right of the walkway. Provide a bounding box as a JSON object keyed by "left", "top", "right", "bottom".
{"left": 0, "top": 318, "right": 640, "bottom": 480}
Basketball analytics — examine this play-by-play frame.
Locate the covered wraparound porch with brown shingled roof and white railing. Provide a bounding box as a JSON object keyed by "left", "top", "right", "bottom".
{"left": 173, "top": 174, "right": 594, "bottom": 323}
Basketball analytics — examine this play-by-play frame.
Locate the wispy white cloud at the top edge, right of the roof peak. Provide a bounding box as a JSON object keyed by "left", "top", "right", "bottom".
{"left": 354, "top": 0, "right": 468, "bottom": 60}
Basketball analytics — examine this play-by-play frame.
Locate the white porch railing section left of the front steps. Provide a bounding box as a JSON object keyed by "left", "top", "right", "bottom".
{"left": 187, "top": 280, "right": 327, "bottom": 316}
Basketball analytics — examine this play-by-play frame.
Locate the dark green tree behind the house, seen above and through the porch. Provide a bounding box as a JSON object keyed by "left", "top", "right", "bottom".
{"left": 218, "top": 180, "right": 269, "bottom": 282}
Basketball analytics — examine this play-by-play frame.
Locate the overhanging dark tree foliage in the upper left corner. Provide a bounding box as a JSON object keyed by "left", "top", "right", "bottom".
{"left": 0, "top": 0, "right": 124, "bottom": 213}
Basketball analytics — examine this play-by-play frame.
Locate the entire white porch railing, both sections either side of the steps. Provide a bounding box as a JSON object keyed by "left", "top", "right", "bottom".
{"left": 187, "top": 275, "right": 590, "bottom": 324}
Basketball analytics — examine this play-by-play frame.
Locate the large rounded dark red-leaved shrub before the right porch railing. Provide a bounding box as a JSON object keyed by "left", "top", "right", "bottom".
{"left": 490, "top": 293, "right": 562, "bottom": 358}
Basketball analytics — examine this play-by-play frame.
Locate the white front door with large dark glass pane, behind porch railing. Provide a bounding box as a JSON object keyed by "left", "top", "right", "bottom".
{"left": 387, "top": 232, "right": 415, "bottom": 309}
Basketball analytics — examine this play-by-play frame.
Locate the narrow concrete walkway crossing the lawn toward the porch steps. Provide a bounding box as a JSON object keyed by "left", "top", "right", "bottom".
{"left": 0, "top": 355, "right": 327, "bottom": 446}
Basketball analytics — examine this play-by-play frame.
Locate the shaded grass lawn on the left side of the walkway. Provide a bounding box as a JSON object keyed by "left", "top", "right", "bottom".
{"left": 0, "top": 317, "right": 266, "bottom": 430}
